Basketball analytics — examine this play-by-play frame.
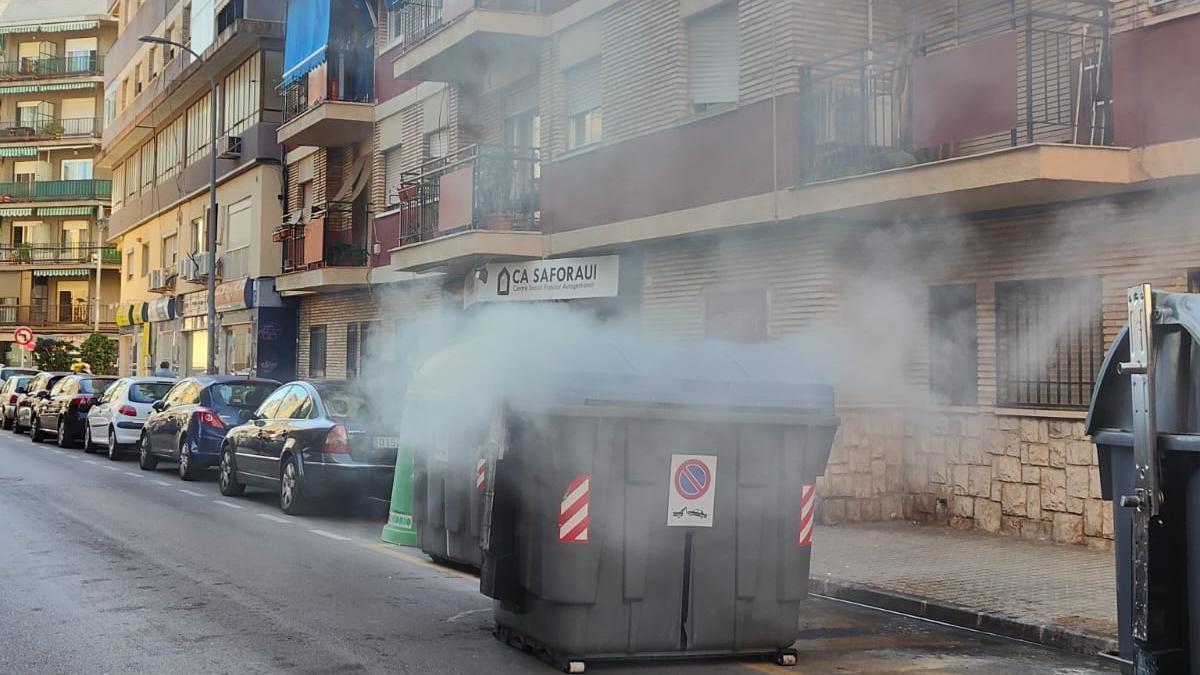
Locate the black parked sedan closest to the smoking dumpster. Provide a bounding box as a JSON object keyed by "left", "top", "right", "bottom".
{"left": 218, "top": 382, "right": 400, "bottom": 514}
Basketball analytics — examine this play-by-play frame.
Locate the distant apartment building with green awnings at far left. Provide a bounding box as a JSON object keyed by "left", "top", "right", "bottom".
{"left": 0, "top": 0, "right": 120, "bottom": 364}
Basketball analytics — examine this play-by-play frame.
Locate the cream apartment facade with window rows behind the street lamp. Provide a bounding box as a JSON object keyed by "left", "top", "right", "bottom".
{"left": 100, "top": 0, "right": 295, "bottom": 380}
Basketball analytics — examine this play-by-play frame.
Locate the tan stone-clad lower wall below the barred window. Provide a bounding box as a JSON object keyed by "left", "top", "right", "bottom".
{"left": 818, "top": 408, "right": 1112, "bottom": 549}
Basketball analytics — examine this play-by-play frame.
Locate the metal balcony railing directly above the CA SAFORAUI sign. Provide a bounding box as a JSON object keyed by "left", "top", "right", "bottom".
{"left": 397, "top": 145, "right": 541, "bottom": 245}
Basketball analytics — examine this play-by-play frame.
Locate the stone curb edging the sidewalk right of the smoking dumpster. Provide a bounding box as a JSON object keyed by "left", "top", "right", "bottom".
{"left": 809, "top": 577, "right": 1117, "bottom": 656}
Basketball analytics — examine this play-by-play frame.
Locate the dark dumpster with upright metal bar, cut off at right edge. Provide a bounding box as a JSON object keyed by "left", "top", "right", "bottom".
{"left": 1087, "top": 285, "right": 1200, "bottom": 674}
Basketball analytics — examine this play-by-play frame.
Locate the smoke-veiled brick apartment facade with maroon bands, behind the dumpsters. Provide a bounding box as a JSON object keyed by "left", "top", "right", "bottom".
{"left": 281, "top": 0, "right": 1200, "bottom": 548}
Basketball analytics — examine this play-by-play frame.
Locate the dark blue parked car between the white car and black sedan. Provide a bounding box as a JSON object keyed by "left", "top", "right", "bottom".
{"left": 138, "top": 375, "right": 280, "bottom": 480}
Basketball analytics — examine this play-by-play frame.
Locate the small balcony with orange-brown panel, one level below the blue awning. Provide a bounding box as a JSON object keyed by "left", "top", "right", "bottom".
{"left": 274, "top": 202, "right": 370, "bottom": 295}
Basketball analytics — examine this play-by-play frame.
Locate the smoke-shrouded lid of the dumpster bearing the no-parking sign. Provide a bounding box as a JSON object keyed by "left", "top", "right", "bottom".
{"left": 408, "top": 339, "right": 834, "bottom": 416}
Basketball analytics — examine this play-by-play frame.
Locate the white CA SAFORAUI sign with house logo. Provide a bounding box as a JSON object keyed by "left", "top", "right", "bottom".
{"left": 463, "top": 256, "right": 620, "bottom": 305}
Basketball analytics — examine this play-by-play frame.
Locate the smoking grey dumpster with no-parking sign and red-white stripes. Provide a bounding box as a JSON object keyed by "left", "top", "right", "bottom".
{"left": 406, "top": 336, "right": 838, "bottom": 671}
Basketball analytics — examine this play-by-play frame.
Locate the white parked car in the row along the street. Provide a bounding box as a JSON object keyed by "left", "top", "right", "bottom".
{"left": 83, "top": 377, "right": 175, "bottom": 461}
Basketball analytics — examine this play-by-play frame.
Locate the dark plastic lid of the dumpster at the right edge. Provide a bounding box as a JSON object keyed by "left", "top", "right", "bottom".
{"left": 1085, "top": 292, "right": 1200, "bottom": 437}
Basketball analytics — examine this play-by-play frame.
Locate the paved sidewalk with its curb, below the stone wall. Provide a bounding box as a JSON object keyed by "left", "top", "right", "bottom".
{"left": 810, "top": 521, "right": 1117, "bottom": 653}
